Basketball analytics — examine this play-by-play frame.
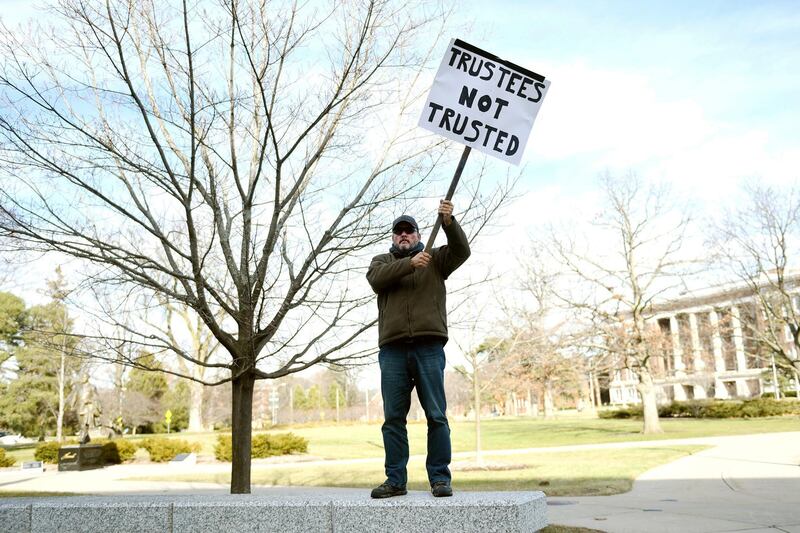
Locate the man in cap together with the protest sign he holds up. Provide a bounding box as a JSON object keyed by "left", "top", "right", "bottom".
{"left": 367, "top": 39, "right": 550, "bottom": 498}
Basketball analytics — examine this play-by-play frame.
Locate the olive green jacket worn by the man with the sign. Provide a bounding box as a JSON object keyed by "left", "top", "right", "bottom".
{"left": 367, "top": 218, "right": 470, "bottom": 346}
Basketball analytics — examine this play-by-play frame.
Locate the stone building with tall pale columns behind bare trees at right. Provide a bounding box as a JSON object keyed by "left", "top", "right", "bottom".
{"left": 608, "top": 276, "right": 800, "bottom": 404}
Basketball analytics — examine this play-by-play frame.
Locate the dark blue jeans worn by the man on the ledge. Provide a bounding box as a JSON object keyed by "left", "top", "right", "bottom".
{"left": 378, "top": 337, "right": 451, "bottom": 486}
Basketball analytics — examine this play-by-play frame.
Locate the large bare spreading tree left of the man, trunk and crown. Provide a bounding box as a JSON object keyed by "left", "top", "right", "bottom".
{"left": 0, "top": 0, "right": 482, "bottom": 493}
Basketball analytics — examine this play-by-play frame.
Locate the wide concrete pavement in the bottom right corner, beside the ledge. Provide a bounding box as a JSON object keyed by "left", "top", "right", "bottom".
{"left": 548, "top": 432, "right": 800, "bottom": 533}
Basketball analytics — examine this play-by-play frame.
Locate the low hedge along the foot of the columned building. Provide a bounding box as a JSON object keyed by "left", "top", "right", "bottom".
{"left": 600, "top": 398, "right": 800, "bottom": 419}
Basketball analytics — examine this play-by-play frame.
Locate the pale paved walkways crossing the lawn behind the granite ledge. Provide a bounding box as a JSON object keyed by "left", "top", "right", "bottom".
{"left": 0, "top": 432, "right": 800, "bottom": 533}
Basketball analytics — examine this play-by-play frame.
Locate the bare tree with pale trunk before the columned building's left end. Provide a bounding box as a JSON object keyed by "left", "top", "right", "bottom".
{"left": 549, "top": 174, "right": 690, "bottom": 433}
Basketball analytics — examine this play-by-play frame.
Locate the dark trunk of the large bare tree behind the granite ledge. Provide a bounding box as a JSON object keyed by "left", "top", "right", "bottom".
{"left": 231, "top": 372, "right": 255, "bottom": 494}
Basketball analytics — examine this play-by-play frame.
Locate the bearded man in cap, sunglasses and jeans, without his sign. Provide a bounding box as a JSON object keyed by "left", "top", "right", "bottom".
{"left": 367, "top": 200, "right": 470, "bottom": 498}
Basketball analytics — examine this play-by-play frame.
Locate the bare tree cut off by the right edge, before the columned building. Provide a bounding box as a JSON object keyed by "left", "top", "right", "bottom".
{"left": 710, "top": 184, "right": 800, "bottom": 379}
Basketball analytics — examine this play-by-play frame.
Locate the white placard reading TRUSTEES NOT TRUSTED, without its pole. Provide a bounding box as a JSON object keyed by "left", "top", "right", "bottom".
{"left": 419, "top": 39, "right": 550, "bottom": 165}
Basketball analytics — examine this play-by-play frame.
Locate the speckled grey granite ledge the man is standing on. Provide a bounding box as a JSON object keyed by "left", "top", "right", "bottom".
{"left": 0, "top": 488, "right": 547, "bottom": 533}
